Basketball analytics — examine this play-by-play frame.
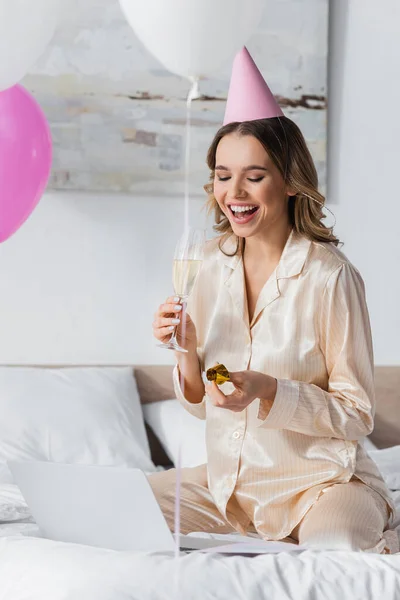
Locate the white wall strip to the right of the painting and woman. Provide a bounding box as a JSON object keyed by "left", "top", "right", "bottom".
{"left": 328, "top": 0, "right": 400, "bottom": 365}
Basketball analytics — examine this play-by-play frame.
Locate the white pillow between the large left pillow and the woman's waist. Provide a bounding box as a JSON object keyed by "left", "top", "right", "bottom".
{"left": 143, "top": 400, "right": 207, "bottom": 467}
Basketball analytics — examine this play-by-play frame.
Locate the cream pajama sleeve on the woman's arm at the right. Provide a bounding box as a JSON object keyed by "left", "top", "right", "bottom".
{"left": 258, "top": 263, "right": 375, "bottom": 441}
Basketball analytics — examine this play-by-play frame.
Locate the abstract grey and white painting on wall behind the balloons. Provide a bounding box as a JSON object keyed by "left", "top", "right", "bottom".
{"left": 22, "top": 0, "right": 329, "bottom": 200}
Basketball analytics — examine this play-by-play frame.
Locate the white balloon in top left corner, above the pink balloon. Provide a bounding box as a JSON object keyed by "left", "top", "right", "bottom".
{"left": 0, "top": 0, "right": 60, "bottom": 91}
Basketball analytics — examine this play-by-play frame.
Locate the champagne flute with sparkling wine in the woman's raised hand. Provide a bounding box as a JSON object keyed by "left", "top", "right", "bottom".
{"left": 157, "top": 227, "right": 205, "bottom": 352}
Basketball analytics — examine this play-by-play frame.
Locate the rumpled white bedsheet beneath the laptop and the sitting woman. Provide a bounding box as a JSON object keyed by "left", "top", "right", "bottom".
{"left": 0, "top": 447, "right": 400, "bottom": 600}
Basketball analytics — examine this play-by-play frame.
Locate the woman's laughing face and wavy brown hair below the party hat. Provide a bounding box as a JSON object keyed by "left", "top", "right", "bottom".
{"left": 204, "top": 116, "right": 339, "bottom": 251}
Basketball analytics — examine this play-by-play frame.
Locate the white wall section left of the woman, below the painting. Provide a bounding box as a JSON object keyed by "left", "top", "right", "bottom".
{"left": 0, "top": 192, "right": 209, "bottom": 364}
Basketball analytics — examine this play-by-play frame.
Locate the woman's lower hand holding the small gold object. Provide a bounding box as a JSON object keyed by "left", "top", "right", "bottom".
{"left": 205, "top": 371, "right": 277, "bottom": 412}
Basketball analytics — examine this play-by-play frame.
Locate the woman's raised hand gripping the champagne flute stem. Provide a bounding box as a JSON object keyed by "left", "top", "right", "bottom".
{"left": 153, "top": 297, "right": 197, "bottom": 352}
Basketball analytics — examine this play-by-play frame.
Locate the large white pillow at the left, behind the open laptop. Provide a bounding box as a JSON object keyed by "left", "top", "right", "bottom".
{"left": 0, "top": 367, "right": 155, "bottom": 483}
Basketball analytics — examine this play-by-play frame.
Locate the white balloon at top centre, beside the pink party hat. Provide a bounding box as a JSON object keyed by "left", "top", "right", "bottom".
{"left": 120, "top": 0, "right": 266, "bottom": 77}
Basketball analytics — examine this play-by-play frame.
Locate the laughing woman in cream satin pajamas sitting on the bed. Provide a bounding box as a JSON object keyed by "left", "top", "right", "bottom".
{"left": 150, "top": 48, "right": 397, "bottom": 552}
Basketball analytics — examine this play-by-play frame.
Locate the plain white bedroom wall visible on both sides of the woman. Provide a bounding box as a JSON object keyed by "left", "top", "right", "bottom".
{"left": 0, "top": 0, "right": 400, "bottom": 365}
